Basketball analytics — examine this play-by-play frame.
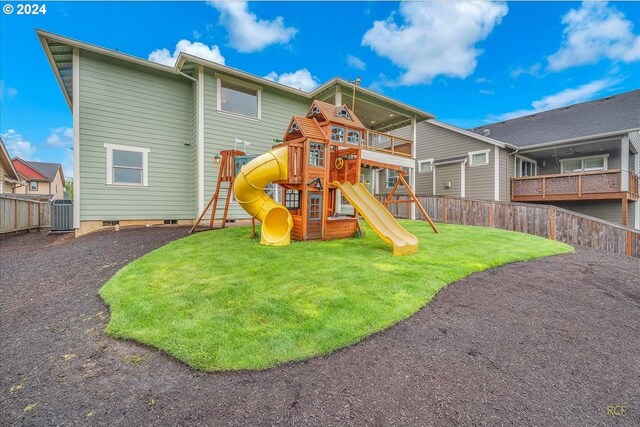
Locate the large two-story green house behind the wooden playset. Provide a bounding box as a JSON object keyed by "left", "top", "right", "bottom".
{"left": 37, "top": 30, "right": 433, "bottom": 234}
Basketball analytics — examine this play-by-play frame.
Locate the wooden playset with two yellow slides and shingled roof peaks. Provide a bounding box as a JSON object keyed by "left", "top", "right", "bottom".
{"left": 192, "top": 100, "right": 437, "bottom": 255}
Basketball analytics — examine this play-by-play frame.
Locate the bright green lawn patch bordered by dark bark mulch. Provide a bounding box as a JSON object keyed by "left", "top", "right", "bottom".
{"left": 100, "top": 221, "right": 572, "bottom": 371}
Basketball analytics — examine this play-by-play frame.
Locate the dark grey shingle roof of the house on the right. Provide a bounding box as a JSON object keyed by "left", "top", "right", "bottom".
{"left": 470, "top": 89, "right": 640, "bottom": 147}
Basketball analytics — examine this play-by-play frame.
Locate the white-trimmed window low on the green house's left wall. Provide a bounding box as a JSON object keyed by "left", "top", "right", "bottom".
{"left": 104, "top": 144, "right": 150, "bottom": 187}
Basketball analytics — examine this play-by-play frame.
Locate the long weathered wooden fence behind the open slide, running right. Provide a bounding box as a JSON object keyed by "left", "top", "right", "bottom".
{"left": 378, "top": 196, "right": 640, "bottom": 258}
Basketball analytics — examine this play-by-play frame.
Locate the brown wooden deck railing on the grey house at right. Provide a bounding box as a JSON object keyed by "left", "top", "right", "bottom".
{"left": 511, "top": 169, "right": 638, "bottom": 202}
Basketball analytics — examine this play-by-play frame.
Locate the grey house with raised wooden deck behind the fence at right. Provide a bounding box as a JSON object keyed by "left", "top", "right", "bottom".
{"left": 410, "top": 90, "right": 640, "bottom": 229}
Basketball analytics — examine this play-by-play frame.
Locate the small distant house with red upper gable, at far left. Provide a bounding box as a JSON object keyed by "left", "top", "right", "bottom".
{"left": 13, "top": 157, "right": 64, "bottom": 200}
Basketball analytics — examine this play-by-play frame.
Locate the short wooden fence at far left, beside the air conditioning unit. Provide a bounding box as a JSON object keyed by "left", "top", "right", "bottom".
{"left": 0, "top": 195, "right": 51, "bottom": 235}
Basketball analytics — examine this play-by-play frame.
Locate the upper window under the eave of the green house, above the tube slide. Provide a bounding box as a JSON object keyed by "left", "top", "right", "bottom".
{"left": 218, "top": 78, "right": 262, "bottom": 119}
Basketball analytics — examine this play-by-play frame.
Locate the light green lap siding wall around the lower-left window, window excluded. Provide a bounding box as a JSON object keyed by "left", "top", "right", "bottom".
{"left": 78, "top": 51, "right": 196, "bottom": 221}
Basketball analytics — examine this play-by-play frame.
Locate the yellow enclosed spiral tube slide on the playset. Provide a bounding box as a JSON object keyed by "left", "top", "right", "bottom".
{"left": 233, "top": 147, "right": 293, "bottom": 246}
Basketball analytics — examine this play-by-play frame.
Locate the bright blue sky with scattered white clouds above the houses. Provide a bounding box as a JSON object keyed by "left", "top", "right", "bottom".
{"left": 0, "top": 1, "right": 640, "bottom": 176}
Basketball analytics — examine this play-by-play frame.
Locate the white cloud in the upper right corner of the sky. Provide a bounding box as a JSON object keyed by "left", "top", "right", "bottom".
{"left": 547, "top": 2, "right": 640, "bottom": 71}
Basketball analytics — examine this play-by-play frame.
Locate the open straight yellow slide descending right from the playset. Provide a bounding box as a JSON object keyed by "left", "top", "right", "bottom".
{"left": 333, "top": 181, "right": 418, "bottom": 256}
